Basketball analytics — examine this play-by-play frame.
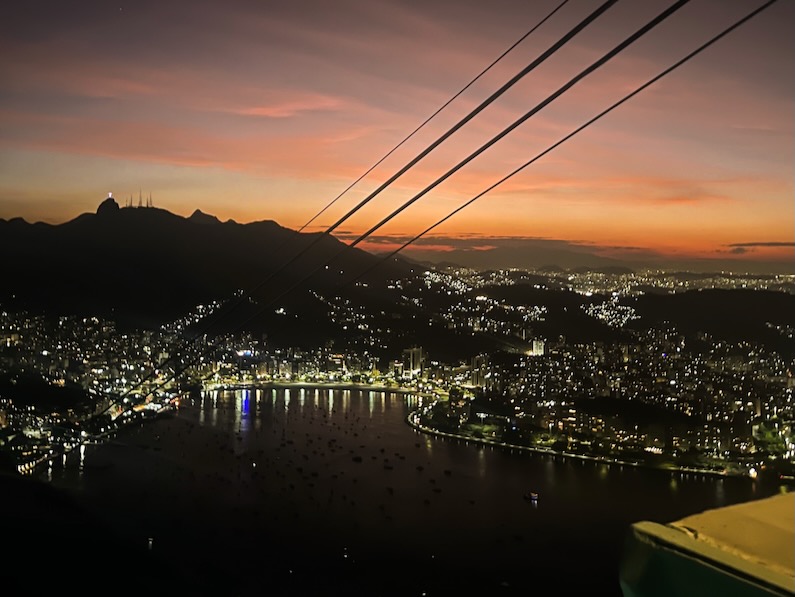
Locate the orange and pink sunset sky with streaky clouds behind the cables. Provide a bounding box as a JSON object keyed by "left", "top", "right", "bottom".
{"left": 0, "top": 0, "right": 795, "bottom": 273}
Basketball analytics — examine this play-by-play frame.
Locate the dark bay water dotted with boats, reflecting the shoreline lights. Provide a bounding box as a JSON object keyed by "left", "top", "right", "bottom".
{"left": 44, "top": 389, "right": 779, "bottom": 596}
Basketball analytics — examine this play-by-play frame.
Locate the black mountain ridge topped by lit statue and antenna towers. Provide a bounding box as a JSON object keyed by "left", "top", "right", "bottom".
{"left": 0, "top": 198, "right": 411, "bottom": 325}
